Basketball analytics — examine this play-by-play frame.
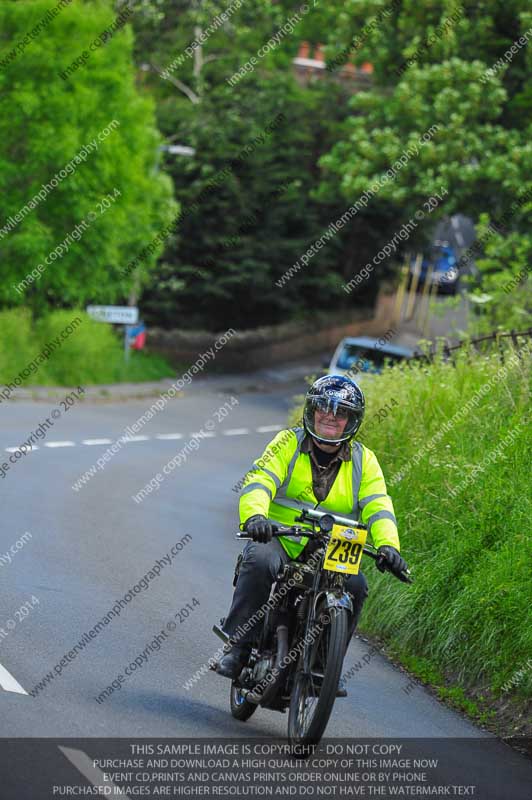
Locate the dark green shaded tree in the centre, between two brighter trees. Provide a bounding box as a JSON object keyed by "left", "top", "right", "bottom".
{"left": 143, "top": 75, "right": 362, "bottom": 328}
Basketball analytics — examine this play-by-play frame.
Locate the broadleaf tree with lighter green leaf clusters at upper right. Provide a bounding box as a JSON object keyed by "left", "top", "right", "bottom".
{"left": 319, "top": 0, "right": 532, "bottom": 324}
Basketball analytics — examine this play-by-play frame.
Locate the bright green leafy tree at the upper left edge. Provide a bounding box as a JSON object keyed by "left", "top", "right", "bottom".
{"left": 0, "top": 0, "right": 177, "bottom": 312}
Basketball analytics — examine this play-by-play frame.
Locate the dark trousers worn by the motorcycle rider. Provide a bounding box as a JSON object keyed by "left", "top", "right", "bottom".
{"left": 223, "top": 539, "right": 368, "bottom": 647}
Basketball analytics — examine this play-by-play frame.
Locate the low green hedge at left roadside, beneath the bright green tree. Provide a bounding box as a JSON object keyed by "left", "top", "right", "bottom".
{"left": 0, "top": 309, "right": 175, "bottom": 387}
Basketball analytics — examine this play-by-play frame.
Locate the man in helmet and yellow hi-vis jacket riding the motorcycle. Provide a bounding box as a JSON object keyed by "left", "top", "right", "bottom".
{"left": 217, "top": 375, "right": 407, "bottom": 696}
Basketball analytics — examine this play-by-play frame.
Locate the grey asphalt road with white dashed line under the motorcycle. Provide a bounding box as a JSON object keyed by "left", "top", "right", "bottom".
{"left": 0, "top": 371, "right": 525, "bottom": 798}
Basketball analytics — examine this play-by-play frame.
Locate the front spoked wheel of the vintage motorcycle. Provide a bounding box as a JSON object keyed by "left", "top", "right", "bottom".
{"left": 288, "top": 608, "right": 348, "bottom": 746}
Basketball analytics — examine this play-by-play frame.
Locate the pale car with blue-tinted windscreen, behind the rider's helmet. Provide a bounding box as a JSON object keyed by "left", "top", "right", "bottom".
{"left": 328, "top": 336, "right": 414, "bottom": 380}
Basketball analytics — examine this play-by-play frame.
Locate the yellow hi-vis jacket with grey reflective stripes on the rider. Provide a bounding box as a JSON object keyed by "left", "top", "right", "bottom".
{"left": 239, "top": 428, "right": 399, "bottom": 558}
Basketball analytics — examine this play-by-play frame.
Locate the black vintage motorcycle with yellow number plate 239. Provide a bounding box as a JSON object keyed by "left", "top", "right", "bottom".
{"left": 212, "top": 509, "right": 412, "bottom": 755}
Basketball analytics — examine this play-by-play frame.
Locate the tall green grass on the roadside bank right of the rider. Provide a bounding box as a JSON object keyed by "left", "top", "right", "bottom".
{"left": 294, "top": 340, "right": 532, "bottom": 699}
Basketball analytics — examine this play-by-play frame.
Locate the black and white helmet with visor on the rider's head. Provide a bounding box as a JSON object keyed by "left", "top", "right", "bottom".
{"left": 303, "top": 375, "right": 365, "bottom": 444}
